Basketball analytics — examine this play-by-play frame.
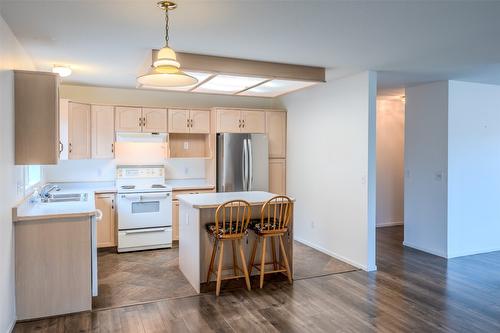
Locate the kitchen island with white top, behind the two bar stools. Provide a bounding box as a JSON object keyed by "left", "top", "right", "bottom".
{"left": 178, "top": 191, "right": 293, "bottom": 293}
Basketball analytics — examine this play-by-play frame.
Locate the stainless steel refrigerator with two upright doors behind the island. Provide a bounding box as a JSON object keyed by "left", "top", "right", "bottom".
{"left": 217, "top": 133, "right": 269, "bottom": 192}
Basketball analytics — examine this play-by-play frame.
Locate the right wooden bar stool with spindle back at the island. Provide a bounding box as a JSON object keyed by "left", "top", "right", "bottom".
{"left": 248, "top": 195, "right": 293, "bottom": 288}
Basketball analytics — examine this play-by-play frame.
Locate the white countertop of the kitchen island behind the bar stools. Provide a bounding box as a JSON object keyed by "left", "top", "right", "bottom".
{"left": 177, "top": 191, "right": 293, "bottom": 208}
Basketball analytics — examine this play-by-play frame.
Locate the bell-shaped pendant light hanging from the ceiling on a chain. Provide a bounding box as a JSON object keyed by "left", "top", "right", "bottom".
{"left": 137, "top": 1, "right": 198, "bottom": 88}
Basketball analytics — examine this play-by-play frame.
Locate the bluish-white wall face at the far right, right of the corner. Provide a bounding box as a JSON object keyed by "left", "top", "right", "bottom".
{"left": 448, "top": 81, "right": 500, "bottom": 257}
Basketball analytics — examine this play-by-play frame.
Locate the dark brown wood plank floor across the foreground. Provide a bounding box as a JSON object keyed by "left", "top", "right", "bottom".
{"left": 15, "top": 227, "right": 500, "bottom": 333}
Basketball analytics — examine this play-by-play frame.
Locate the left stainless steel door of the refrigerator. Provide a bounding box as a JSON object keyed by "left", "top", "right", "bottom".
{"left": 217, "top": 133, "right": 249, "bottom": 192}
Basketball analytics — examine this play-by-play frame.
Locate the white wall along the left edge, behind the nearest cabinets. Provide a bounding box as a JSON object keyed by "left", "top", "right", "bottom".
{"left": 0, "top": 12, "right": 33, "bottom": 332}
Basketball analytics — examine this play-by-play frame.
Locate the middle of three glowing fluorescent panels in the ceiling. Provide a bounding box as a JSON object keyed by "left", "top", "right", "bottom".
{"left": 193, "top": 75, "right": 268, "bottom": 94}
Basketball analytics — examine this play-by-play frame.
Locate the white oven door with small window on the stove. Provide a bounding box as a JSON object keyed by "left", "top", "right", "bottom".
{"left": 117, "top": 192, "right": 172, "bottom": 230}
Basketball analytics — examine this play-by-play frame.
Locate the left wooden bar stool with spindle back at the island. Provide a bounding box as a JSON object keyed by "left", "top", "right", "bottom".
{"left": 205, "top": 200, "right": 252, "bottom": 296}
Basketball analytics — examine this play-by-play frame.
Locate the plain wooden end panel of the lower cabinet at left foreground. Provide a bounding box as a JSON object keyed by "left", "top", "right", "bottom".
{"left": 14, "top": 216, "right": 92, "bottom": 320}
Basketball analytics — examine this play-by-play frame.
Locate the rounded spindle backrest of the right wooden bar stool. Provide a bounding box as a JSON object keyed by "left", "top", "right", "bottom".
{"left": 260, "top": 195, "right": 293, "bottom": 233}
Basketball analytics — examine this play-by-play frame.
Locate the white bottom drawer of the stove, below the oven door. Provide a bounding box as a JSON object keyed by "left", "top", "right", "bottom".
{"left": 118, "top": 227, "right": 172, "bottom": 252}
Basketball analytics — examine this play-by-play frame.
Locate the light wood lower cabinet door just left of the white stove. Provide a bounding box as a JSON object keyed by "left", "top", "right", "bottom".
{"left": 95, "top": 194, "right": 116, "bottom": 247}
